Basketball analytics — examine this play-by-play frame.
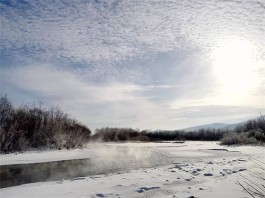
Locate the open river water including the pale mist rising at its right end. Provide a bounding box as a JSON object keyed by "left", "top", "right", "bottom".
{"left": 0, "top": 148, "right": 171, "bottom": 188}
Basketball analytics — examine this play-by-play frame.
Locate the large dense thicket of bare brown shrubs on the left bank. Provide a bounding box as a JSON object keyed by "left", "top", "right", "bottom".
{"left": 0, "top": 95, "right": 91, "bottom": 153}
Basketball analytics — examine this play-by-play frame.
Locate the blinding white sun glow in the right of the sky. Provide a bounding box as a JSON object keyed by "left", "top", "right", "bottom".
{"left": 212, "top": 40, "right": 258, "bottom": 92}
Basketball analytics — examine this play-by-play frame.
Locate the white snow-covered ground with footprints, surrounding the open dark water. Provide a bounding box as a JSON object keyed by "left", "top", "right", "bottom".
{"left": 0, "top": 142, "right": 265, "bottom": 198}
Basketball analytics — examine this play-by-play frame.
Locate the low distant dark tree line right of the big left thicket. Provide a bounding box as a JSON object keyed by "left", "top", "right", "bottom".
{"left": 91, "top": 116, "right": 265, "bottom": 145}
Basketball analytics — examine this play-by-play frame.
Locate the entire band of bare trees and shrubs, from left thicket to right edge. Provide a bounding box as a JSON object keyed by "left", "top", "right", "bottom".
{"left": 0, "top": 95, "right": 265, "bottom": 153}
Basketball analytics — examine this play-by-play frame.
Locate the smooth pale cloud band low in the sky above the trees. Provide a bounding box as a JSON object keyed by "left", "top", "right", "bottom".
{"left": 1, "top": 64, "right": 258, "bottom": 129}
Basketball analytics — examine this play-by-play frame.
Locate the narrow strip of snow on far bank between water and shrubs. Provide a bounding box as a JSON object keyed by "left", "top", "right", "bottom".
{"left": 0, "top": 142, "right": 235, "bottom": 165}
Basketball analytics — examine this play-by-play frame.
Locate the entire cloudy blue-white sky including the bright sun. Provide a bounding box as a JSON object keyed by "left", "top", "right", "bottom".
{"left": 0, "top": 0, "right": 265, "bottom": 130}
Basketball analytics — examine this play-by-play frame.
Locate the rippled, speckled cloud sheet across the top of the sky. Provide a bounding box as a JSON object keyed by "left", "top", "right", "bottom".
{"left": 0, "top": 0, "right": 265, "bottom": 64}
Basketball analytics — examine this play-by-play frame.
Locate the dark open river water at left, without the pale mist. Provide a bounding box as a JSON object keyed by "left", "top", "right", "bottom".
{"left": 0, "top": 159, "right": 95, "bottom": 188}
